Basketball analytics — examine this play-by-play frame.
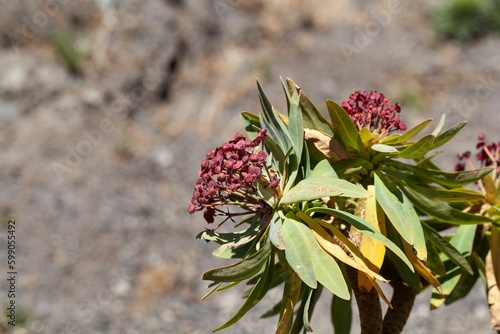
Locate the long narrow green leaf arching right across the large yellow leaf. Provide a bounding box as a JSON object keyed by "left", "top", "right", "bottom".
{"left": 304, "top": 207, "right": 413, "bottom": 271}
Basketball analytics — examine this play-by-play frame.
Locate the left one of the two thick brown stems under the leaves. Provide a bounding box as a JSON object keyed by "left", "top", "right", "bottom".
{"left": 346, "top": 266, "right": 382, "bottom": 334}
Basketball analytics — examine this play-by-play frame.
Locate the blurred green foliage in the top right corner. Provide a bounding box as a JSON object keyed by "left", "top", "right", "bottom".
{"left": 431, "top": 0, "right": 500, "bottom": 42}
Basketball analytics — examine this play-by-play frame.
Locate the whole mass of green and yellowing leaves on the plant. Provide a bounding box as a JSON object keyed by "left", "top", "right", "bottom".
{"left": 189, "top": 79, "right": 500, "bottom": 333}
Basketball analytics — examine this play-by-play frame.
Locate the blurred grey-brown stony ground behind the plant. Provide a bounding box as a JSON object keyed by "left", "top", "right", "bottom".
{"left": 0, "top": 0, "right": 500, "bottom": 334}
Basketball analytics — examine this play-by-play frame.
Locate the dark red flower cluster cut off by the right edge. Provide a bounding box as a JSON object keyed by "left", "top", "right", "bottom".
{"left": 455, "top": 133, "right": 500, "bottom": 174}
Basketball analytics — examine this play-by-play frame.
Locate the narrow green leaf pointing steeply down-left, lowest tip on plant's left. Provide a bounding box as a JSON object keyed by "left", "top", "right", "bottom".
{"left": 213, "top": 254, "right": 274, "bottom": 332}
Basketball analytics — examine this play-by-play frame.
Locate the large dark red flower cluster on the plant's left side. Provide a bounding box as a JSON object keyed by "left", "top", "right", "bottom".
{"left": 188, "top": 129, "right": 279, "bottom": 223}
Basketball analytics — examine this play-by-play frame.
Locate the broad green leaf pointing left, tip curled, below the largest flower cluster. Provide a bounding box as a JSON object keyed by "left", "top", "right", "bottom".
{"left": 202, "top": 243, "right": 271, "bottom": 282}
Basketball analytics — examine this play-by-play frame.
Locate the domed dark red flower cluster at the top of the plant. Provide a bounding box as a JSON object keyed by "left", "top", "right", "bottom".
{"left": 342, "top": 91, "right": 406, "bottom": 134}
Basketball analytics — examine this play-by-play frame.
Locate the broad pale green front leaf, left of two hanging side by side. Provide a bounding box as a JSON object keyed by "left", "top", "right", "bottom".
{"left": 283, "top": 218, "right": 317, "bottom": 289}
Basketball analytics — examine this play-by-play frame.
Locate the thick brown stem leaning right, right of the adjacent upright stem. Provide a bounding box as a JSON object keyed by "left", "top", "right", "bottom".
{"left": 382, "top": 275, "right": 415, "bottom": 334}
